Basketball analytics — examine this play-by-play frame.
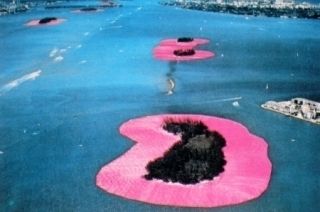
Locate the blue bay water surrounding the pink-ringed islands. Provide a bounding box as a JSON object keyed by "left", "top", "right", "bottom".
{"left": 0, "top": 0, "right": 320, "bottom": 211}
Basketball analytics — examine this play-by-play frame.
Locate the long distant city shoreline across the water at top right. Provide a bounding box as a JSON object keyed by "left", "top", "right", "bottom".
{"left": 160, "top": 0, "right": 320, "bottom": 19}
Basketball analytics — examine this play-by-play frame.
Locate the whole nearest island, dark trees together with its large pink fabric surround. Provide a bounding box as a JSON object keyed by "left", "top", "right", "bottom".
{"left": 96, "top": 114, "right": 272, "bottom": 207}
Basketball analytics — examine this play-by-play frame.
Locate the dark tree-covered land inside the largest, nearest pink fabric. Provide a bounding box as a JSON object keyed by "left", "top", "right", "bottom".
{"left": 144, "top": 120, "right": 226, "bottom": 184}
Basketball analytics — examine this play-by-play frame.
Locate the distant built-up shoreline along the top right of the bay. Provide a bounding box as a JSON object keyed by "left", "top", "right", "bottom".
{"left": 160, "top": 0, "right": 320, "bottom": 19}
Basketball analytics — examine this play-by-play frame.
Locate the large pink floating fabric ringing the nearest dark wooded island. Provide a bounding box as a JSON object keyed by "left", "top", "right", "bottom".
{"left": 96, "top": 115, "right": 271, "bottom": 207}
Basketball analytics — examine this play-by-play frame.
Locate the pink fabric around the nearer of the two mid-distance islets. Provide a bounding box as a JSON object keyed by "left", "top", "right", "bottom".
{"left": 153, "top": 46, "right": 214, "bottom": 61}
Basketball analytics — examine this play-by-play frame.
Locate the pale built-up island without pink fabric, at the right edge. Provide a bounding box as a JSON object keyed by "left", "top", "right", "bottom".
{"left": 261, "top": 98, "right": 320, "bottom": 124}
